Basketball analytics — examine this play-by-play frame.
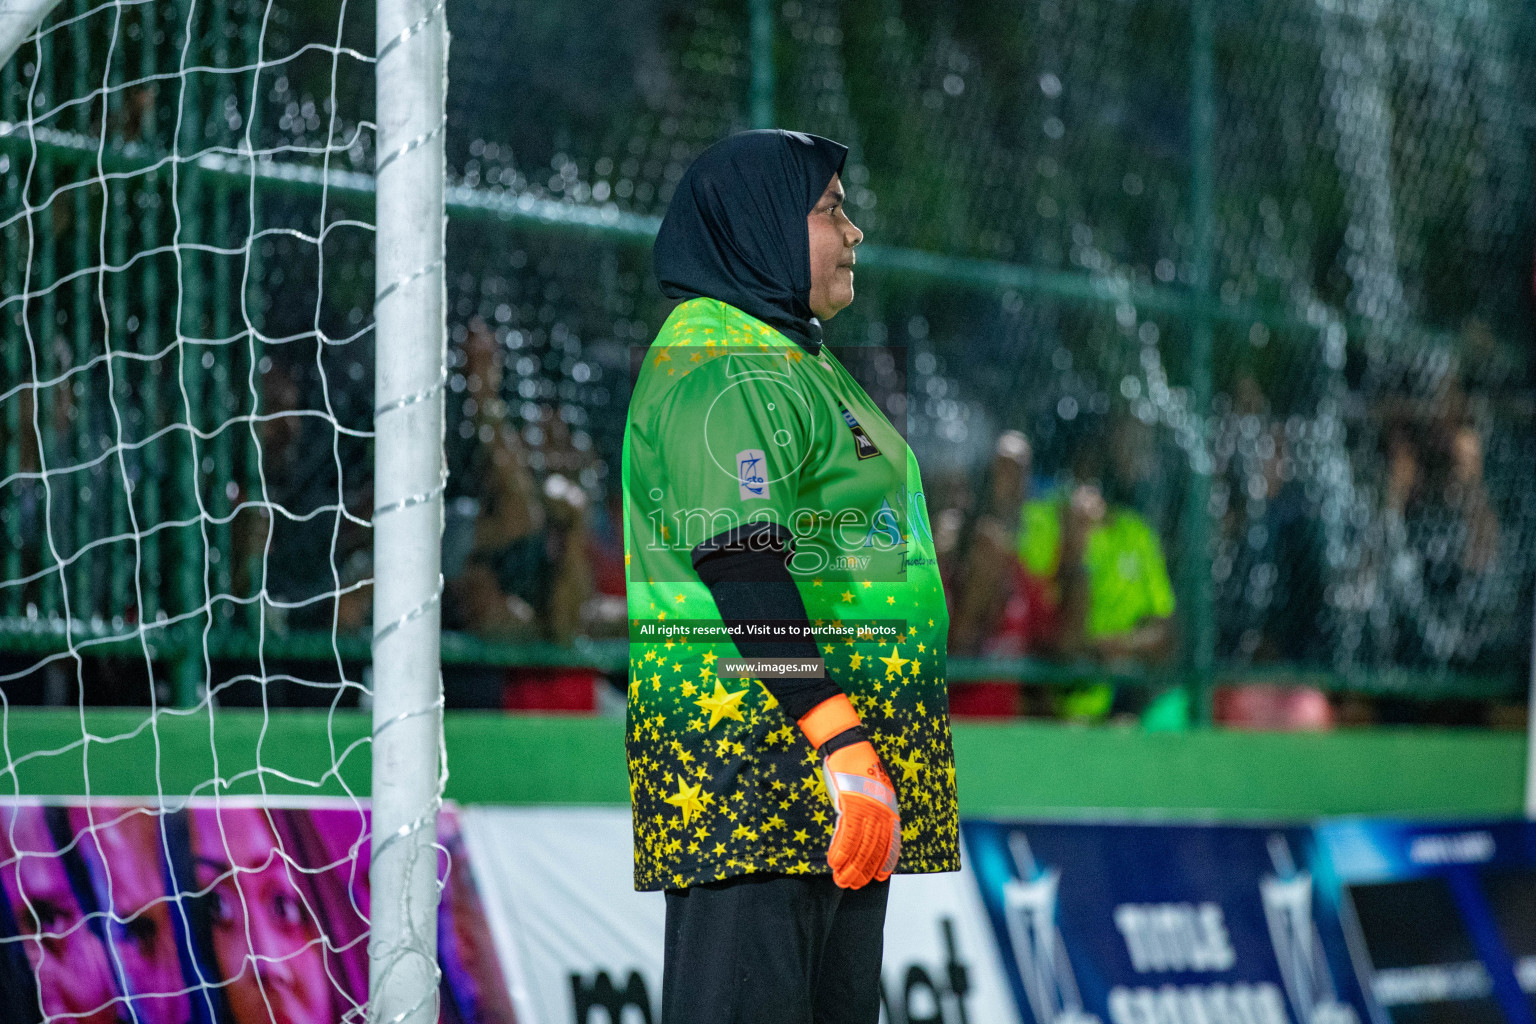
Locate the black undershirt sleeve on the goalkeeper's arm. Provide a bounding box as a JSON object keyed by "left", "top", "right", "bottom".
{"left": 693, "top": 524, "right": 843, "bottom": 720}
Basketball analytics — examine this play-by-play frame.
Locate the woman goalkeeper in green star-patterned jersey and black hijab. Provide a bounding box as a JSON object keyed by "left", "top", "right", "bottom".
{"left": 622, "top": 130, "right": 960, "bottom": 1024}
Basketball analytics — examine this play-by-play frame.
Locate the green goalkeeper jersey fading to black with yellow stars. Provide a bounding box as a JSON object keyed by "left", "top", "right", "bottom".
{"left": 622, "top": 298, "right": 960, "bottom": 889}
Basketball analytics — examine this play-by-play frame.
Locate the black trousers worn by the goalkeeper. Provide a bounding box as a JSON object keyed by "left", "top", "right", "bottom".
{"left": 660, "top": 875, "right": 891, "bottom": 1024}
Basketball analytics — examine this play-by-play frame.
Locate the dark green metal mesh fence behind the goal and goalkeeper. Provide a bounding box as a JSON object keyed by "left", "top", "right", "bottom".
{"left": 0, "top": 0, "right": 1536, "bottom": 712}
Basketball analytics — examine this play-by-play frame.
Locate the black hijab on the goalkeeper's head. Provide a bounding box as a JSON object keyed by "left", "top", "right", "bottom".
{"left": 653, "top": 129, "right": 848, "bottom": 355}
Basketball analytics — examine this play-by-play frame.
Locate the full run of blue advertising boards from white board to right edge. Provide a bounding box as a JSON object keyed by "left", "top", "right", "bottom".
{"left": 963, "top": 818, "right": 1536, "bottom": 1024}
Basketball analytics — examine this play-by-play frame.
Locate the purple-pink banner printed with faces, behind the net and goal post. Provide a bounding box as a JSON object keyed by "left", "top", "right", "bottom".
{"left": 0, "top": 800, "right": 516, "bottom": 1024}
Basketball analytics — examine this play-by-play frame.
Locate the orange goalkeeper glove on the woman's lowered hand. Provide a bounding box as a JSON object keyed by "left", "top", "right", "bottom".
{"left": 799, "top": 694, "right": 902, "bottom": 889}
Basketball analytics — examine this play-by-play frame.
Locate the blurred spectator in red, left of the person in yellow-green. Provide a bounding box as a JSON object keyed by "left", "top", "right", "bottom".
{"left": 946, "top": 430, "right": 1055, "bottom": 717}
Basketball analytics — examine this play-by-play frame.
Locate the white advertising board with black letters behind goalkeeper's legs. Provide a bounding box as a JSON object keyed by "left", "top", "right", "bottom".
{"left": 461, "top": 808, "right": 1018, "bottom": 1024}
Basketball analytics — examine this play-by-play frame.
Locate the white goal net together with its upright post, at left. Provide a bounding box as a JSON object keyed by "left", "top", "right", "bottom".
{"left": 0, "top": 0, "right": 447, "bottom": 1024}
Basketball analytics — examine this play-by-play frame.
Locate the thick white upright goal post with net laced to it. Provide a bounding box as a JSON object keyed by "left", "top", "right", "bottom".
{"left": 369, "top": 0, "right": 449, "bottom": 1024}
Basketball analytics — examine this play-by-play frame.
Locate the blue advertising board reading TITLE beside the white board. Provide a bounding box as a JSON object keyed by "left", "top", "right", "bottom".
{"left": 965, "top": 821, "right": 1370, "bottom": 1024}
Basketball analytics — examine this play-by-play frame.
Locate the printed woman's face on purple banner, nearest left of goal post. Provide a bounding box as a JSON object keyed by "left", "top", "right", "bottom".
{"left": 192, "top": 808, "right": 332, "bottom": 1024}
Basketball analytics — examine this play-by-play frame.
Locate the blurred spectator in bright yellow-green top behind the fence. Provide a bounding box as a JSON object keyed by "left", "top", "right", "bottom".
{"left": 1018, "top": 418, "right": 1189, "bottom": 729}
